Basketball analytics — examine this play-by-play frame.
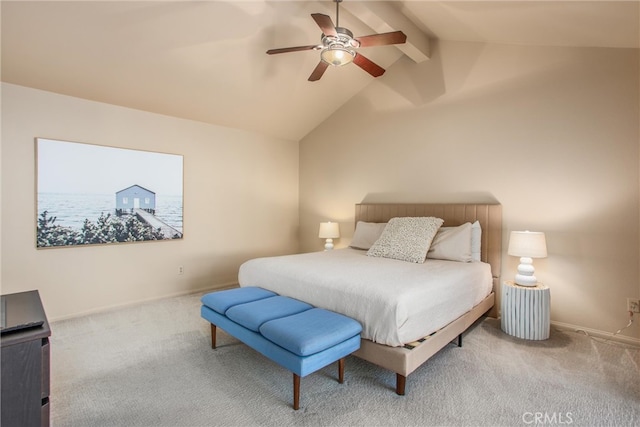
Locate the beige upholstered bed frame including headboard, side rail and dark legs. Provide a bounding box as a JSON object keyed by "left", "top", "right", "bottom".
{"left": 354, "top": 203, "right": 502, "bottom": 395}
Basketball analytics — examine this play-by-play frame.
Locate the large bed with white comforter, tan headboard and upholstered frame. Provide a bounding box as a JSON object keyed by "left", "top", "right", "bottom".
{"left": 238, "top": 203, "right": 502, "bottom": 395}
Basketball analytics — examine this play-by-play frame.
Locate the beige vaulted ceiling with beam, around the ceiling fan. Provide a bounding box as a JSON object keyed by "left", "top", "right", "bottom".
{"left": 1, "top": 0, "right": 640, "bottom": 141}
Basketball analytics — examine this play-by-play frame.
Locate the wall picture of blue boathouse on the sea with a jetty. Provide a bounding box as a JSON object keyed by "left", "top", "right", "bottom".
{"left": 36, "top": 138, "right": 183, "bottom": 248}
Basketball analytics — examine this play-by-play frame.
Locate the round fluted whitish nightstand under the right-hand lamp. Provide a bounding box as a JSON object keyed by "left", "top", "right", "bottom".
{"left": 501, "top": 281, "right": 551, "bottom": 340}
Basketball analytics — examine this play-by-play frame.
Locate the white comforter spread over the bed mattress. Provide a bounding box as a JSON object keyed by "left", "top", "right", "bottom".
{"left": 238, "top": 248, "right": 492, "bottom": 346}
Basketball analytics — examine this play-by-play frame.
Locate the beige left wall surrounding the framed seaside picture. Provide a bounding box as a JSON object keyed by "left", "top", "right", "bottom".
{"left": 1, "top": 84, "right": 298, "bottom": 319}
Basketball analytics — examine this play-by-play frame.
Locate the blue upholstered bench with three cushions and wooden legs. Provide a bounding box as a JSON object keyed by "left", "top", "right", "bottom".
{"left": 201, "top": 287, "right": 362, "bottom": 410}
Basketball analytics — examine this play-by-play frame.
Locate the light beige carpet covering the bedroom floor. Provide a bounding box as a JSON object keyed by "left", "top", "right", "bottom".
{"left": 51, "top": 294, "right": 640, "bottom": 426}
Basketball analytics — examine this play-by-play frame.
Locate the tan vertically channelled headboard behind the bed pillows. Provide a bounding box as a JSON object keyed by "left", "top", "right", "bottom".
{"left": 355, "top": 203, "right": 502, "bottom": 286}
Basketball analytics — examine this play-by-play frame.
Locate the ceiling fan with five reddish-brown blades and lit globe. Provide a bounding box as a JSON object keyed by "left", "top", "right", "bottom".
{"left": 267, "top": 0, "right": 407, "bottom": 82}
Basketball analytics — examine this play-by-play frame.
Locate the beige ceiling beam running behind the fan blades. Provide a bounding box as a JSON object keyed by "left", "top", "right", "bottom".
{"left": 340, "top": 1, "right": 431, "bottom": 63}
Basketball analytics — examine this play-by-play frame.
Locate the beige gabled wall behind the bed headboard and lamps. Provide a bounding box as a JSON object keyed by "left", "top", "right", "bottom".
{"left": 300, "top": 42, "right": 640, "bottom": 339}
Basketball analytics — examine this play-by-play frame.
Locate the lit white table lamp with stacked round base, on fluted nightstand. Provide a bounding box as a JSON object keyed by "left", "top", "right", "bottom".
{"left": 507, "top": 231, "right": 547, "bottom": 286}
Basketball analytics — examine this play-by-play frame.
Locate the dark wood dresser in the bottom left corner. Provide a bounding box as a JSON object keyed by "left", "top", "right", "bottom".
{"left": 0, "top": 291, "right": 51, "bottom": 427}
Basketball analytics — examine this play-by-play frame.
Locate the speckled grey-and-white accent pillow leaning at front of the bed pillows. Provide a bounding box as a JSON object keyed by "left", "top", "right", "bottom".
{"left": 367, "top": 216, "right": 444, "bottom": 264}
